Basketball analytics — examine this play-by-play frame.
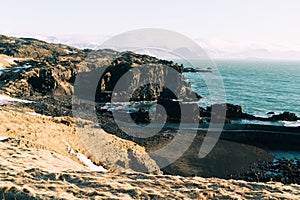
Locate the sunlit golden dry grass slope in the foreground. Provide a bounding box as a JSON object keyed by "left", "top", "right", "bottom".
{"left": 0, "top": 105, "right": 300, "bottom": 199}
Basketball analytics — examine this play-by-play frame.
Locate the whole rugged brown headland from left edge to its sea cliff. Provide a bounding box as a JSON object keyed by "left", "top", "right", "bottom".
{"left": 0, "top": 36, "right": 199, "bottom": 101}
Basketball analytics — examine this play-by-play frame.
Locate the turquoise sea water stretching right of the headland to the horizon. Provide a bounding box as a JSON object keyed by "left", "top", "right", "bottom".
{"left": 183, "top": 60, "right": 300, "bottom": 123}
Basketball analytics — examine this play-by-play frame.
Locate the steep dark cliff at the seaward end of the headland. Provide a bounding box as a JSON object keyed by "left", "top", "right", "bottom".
{"left": 96, "top": 52, "right": 200, "bottom": 101}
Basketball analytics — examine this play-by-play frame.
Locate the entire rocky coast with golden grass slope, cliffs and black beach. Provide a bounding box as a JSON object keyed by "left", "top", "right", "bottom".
{"left": 0, "top": 35, "right": 300, "bottom": 199}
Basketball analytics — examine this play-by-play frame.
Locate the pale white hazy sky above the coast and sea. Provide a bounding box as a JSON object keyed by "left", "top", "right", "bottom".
{"left": 0, "top": 0, "right": 300, "bottom": 59}
